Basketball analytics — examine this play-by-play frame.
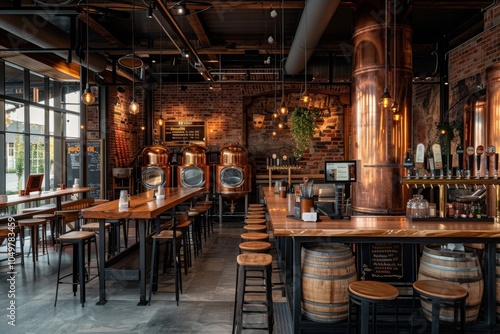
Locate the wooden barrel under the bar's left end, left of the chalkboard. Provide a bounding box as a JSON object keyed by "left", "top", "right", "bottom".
{"left": 301, "top": 243, "right": 357, "bottom": 323}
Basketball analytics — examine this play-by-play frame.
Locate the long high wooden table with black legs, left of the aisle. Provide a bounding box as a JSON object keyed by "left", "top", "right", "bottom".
{"left": 82, "top": 187, "right": 204, "bottom": 305}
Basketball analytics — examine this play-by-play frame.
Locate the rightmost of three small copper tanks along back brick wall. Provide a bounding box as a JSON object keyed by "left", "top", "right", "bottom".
{"left": 216, "top": 144, "right": 252, "bottom": 199}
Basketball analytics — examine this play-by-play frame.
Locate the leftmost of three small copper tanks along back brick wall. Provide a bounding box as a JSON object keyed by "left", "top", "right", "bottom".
{"left": 139, "top": 145, "right": 170, "bottom": 191}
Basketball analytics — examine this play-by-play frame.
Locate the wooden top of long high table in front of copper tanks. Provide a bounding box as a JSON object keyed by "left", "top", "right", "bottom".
{"left": 82, "top": 187, "right": 204, "bottom": 219}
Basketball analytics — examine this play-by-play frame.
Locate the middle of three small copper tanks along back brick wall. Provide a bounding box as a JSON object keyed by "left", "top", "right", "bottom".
{"left": 177, "top": 145, "right": 210, "bottom": 191}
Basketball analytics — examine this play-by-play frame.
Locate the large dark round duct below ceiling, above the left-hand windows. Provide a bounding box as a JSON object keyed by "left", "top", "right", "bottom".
{"left": 0, "top": 15, "right": 107, "bottom": 73}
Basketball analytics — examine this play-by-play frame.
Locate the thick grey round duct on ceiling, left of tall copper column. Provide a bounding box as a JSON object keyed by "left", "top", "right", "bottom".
{"left": 285, "top": 0, "right": 340, "bottom": 75}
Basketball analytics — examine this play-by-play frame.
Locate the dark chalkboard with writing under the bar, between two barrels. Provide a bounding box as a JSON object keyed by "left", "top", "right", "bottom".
{"left": 358, "top": 243, "right": 417, "bottom": 282}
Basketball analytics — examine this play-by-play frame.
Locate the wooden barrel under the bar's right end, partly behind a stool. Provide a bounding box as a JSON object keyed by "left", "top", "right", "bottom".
{"left": 418, "top": 245, "right": 484, "bottom": 324}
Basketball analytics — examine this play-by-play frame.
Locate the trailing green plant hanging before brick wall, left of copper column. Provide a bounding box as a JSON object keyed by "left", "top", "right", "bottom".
{"left": 290, "top": 107, "right": 321, "bottom": 159}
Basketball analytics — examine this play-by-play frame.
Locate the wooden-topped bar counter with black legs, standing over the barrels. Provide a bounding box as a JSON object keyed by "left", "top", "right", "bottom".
{"left": 263, "top": 187, "right": 500, "bottom": 333}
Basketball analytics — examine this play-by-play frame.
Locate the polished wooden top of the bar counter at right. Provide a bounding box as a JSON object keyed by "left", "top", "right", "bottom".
{"left": 263, "top": 187, "right": 500, "bottom": 239}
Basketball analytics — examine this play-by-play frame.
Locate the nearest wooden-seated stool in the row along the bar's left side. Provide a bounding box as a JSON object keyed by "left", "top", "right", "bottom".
{"left": 233, "top": 253, "right": 274, "bottom": 334}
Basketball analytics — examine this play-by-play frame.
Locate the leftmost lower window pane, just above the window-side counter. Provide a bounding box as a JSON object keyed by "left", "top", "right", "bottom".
{"left": 5, "top": 134, "right": 25, "bottom": 194}
